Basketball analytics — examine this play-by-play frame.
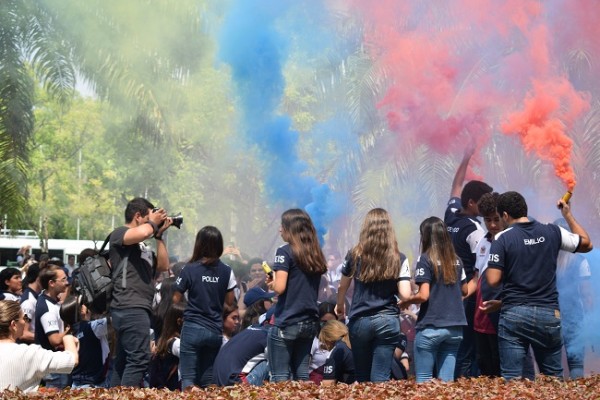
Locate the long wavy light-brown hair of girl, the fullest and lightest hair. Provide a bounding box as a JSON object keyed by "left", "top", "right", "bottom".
{"left": 351, "top": 208, "right": 400, "bottom": 282}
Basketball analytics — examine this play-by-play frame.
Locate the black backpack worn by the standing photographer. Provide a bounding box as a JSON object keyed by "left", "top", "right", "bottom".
{"left": 73, "top": 235, "right": 128, "bottom": 314}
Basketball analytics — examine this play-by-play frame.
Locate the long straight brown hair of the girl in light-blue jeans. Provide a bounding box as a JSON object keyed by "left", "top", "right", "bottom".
{"left": 419, "top": 217, "right": 458, "bottom": 285}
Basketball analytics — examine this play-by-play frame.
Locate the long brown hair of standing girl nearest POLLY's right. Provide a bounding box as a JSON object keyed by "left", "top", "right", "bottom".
{"left": 281, "top": 208, "right": 327, "bottom": 275}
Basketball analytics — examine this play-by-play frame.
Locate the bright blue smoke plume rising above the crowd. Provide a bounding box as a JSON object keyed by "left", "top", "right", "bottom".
{"left": 219, "top": 0, "right": 341, "bottom": 244}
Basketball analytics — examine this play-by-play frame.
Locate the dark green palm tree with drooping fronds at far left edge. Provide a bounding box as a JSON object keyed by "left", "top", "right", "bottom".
{"left": 0, "top": 0, "right": 75, "bottom": 224}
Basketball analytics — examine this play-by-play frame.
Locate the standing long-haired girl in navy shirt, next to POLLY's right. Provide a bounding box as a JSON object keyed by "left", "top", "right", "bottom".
{"left": 267, "top": 209, "right": 327, "bottom": 382}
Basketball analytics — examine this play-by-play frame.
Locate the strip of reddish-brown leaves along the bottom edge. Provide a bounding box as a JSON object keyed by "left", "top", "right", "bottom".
{"left": 0, "top": 375, "right": 600, "bottom": 400}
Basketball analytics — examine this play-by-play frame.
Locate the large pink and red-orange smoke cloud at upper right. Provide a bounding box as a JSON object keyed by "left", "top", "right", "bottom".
{"left": 350, "top": 0, "right": 598, "bottom": 188}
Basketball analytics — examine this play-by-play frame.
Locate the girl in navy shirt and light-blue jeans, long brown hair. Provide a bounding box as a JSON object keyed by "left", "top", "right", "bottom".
{"left": 402, "top": 217, "right": 467, "bottom": 383}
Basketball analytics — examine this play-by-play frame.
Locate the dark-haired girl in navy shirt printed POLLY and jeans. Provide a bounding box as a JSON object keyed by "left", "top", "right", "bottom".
{"left": 173, "top": 226, "right": 236, "bottom": 390}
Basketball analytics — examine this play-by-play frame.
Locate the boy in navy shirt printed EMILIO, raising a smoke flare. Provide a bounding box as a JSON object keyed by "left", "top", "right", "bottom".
{"left": 486, "top": 192, "right": 593, "bottom": 379}
